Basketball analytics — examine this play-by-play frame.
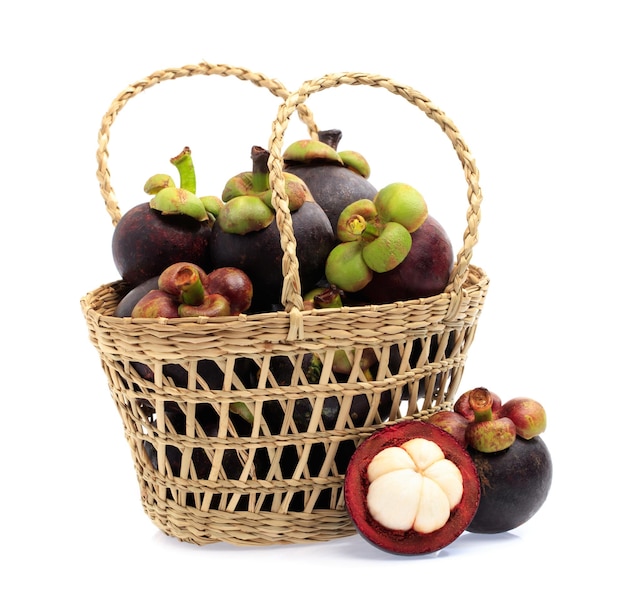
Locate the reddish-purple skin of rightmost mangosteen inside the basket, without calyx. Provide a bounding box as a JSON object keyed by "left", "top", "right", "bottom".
{"left": 357, "top": 215, "right": 454, "bottom": 304}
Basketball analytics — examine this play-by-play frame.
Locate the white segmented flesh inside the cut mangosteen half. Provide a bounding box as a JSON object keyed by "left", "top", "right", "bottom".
{"left": 367, "top": 438, "right": 463, "bottom": 534}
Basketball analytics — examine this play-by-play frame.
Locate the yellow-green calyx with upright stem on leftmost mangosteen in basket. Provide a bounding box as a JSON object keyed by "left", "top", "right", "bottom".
{"left": 144, "top": 147, "right": 221, "bottom": 221}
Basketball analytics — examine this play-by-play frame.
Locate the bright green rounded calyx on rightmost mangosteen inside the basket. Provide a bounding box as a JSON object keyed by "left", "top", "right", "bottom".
{"left": 326, "top": 183, "right": 428, "bottom": 292}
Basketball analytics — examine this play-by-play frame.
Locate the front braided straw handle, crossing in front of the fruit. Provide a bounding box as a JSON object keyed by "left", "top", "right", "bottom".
{"left": 268, "top": 72, "right": 482, "bottom": 332}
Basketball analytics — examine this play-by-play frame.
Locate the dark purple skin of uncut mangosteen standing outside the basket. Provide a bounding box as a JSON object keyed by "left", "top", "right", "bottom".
{"left": 467, "top": 437, "right": 552, "bottom": 534}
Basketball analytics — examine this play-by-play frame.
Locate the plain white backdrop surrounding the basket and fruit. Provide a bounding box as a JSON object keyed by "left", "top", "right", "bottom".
{"left": 0, "top": 0, "right": 626, "bottom": 593}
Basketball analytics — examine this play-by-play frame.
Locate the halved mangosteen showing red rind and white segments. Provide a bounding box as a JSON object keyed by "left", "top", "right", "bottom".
{"left": 345, "top": 420, "right": 480, "bottom": 555}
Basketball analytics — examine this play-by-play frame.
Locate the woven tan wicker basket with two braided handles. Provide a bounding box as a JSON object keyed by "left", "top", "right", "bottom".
{"left": 81, "top": 63, "right": 489, "bottom": 545}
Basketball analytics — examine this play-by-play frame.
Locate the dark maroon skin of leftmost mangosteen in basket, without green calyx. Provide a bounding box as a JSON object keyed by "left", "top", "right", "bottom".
{"left": 112, "top": 202, "right": 211, "bottom": 287}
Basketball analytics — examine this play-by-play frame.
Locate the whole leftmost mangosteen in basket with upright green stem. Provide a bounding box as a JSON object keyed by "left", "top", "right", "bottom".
{"left": 112, "top": 147, "right": 215, "bottom": 287}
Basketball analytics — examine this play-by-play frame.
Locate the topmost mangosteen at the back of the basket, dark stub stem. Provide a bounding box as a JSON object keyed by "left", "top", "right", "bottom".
{"left": 283, "top": 129, "right": 376, "bottom": 233}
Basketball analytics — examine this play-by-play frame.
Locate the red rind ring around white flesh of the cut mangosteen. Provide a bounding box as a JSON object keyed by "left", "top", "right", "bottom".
{"left": 344, "top": 420, "right": 480, "bottom": 555}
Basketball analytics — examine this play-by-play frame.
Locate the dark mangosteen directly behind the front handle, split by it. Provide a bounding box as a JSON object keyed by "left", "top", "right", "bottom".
{"left": 209, "top": 147, "right": 335, "bottom": 312}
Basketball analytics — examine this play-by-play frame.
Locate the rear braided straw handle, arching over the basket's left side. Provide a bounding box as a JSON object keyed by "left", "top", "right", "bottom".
{"left": 96, "top": 62, "right": 317, "bottom": 226}
